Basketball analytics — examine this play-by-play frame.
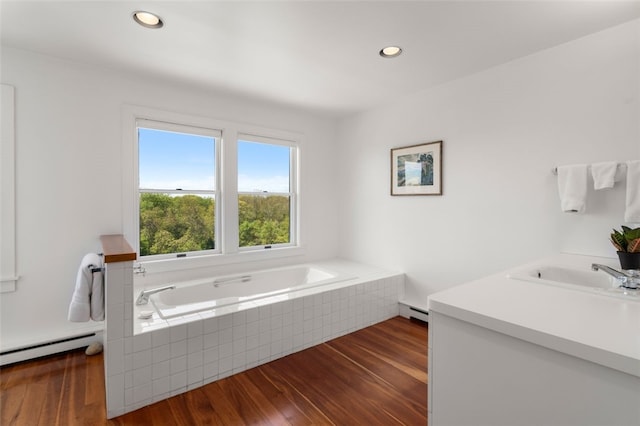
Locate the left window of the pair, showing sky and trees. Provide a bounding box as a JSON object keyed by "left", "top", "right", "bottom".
{"left": 137, "top": 120, "right": 220, "bottom": 257}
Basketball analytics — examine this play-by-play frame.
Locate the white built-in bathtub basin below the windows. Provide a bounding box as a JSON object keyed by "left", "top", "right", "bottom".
{"left": 149, "top": 265, "right": 355, "bottom": 319}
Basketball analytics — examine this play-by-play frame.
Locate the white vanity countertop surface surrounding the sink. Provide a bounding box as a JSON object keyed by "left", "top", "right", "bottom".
{"left": 428, "top": 254, "right": 640, "bottom": 377}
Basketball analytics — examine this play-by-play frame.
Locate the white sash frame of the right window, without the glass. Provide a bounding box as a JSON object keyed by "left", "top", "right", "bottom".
{"left": 236, "top": 133, "right": 299, "bottom": 252}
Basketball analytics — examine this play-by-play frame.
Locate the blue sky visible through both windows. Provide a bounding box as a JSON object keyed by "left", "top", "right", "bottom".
{"left": 138, "top": 128, "right": 289, "bottom": 192}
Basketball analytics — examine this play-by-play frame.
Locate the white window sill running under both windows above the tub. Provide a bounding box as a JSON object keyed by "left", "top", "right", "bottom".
{"left": 138, "top": 247, "right": 306, "bottom": 274}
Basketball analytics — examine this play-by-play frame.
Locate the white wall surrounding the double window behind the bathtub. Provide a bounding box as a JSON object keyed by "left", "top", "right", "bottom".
{"left": 0, "top": 48, "right": 337, "bottom": 350}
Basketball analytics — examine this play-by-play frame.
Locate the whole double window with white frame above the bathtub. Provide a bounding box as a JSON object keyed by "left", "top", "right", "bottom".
{"left": 127, "top": 106, "right": 304, "bottom": 266}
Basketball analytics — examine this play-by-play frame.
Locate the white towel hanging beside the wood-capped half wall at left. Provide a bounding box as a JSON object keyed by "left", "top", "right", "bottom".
{"left": 68, "top": 253, "right": 104, "bottom": 322}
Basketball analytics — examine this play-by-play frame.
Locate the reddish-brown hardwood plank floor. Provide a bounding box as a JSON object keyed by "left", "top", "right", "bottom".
{"left": 0, "top": 317, "right": 427, "bottom": 426}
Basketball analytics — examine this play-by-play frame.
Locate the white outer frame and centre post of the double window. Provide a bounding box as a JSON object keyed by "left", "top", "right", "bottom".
{"left": 122, "top": 105, "right": 306, "bottom": 274}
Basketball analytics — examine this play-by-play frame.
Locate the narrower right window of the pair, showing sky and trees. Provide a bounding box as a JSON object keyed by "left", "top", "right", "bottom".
{"left": 238, "top": 136, "right": 296, "bottom": 248}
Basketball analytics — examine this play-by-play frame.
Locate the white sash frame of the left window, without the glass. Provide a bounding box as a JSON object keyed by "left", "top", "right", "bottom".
{"left": 134, "top": 118, "right": 222, "bottom": 261}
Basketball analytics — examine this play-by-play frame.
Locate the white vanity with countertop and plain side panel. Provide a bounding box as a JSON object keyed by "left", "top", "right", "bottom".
{"left": 428, "top": 255, "right": 640, "bottom": 426}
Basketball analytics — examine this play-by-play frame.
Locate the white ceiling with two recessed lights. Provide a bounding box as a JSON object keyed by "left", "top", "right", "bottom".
{"left": 0, "top": 0, "right": 640, "bottom": 116}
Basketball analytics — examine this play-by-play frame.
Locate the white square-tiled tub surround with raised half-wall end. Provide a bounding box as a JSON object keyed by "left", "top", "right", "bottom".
{"left": 105, "top": 261, "right": 404, "bottom": 418}
